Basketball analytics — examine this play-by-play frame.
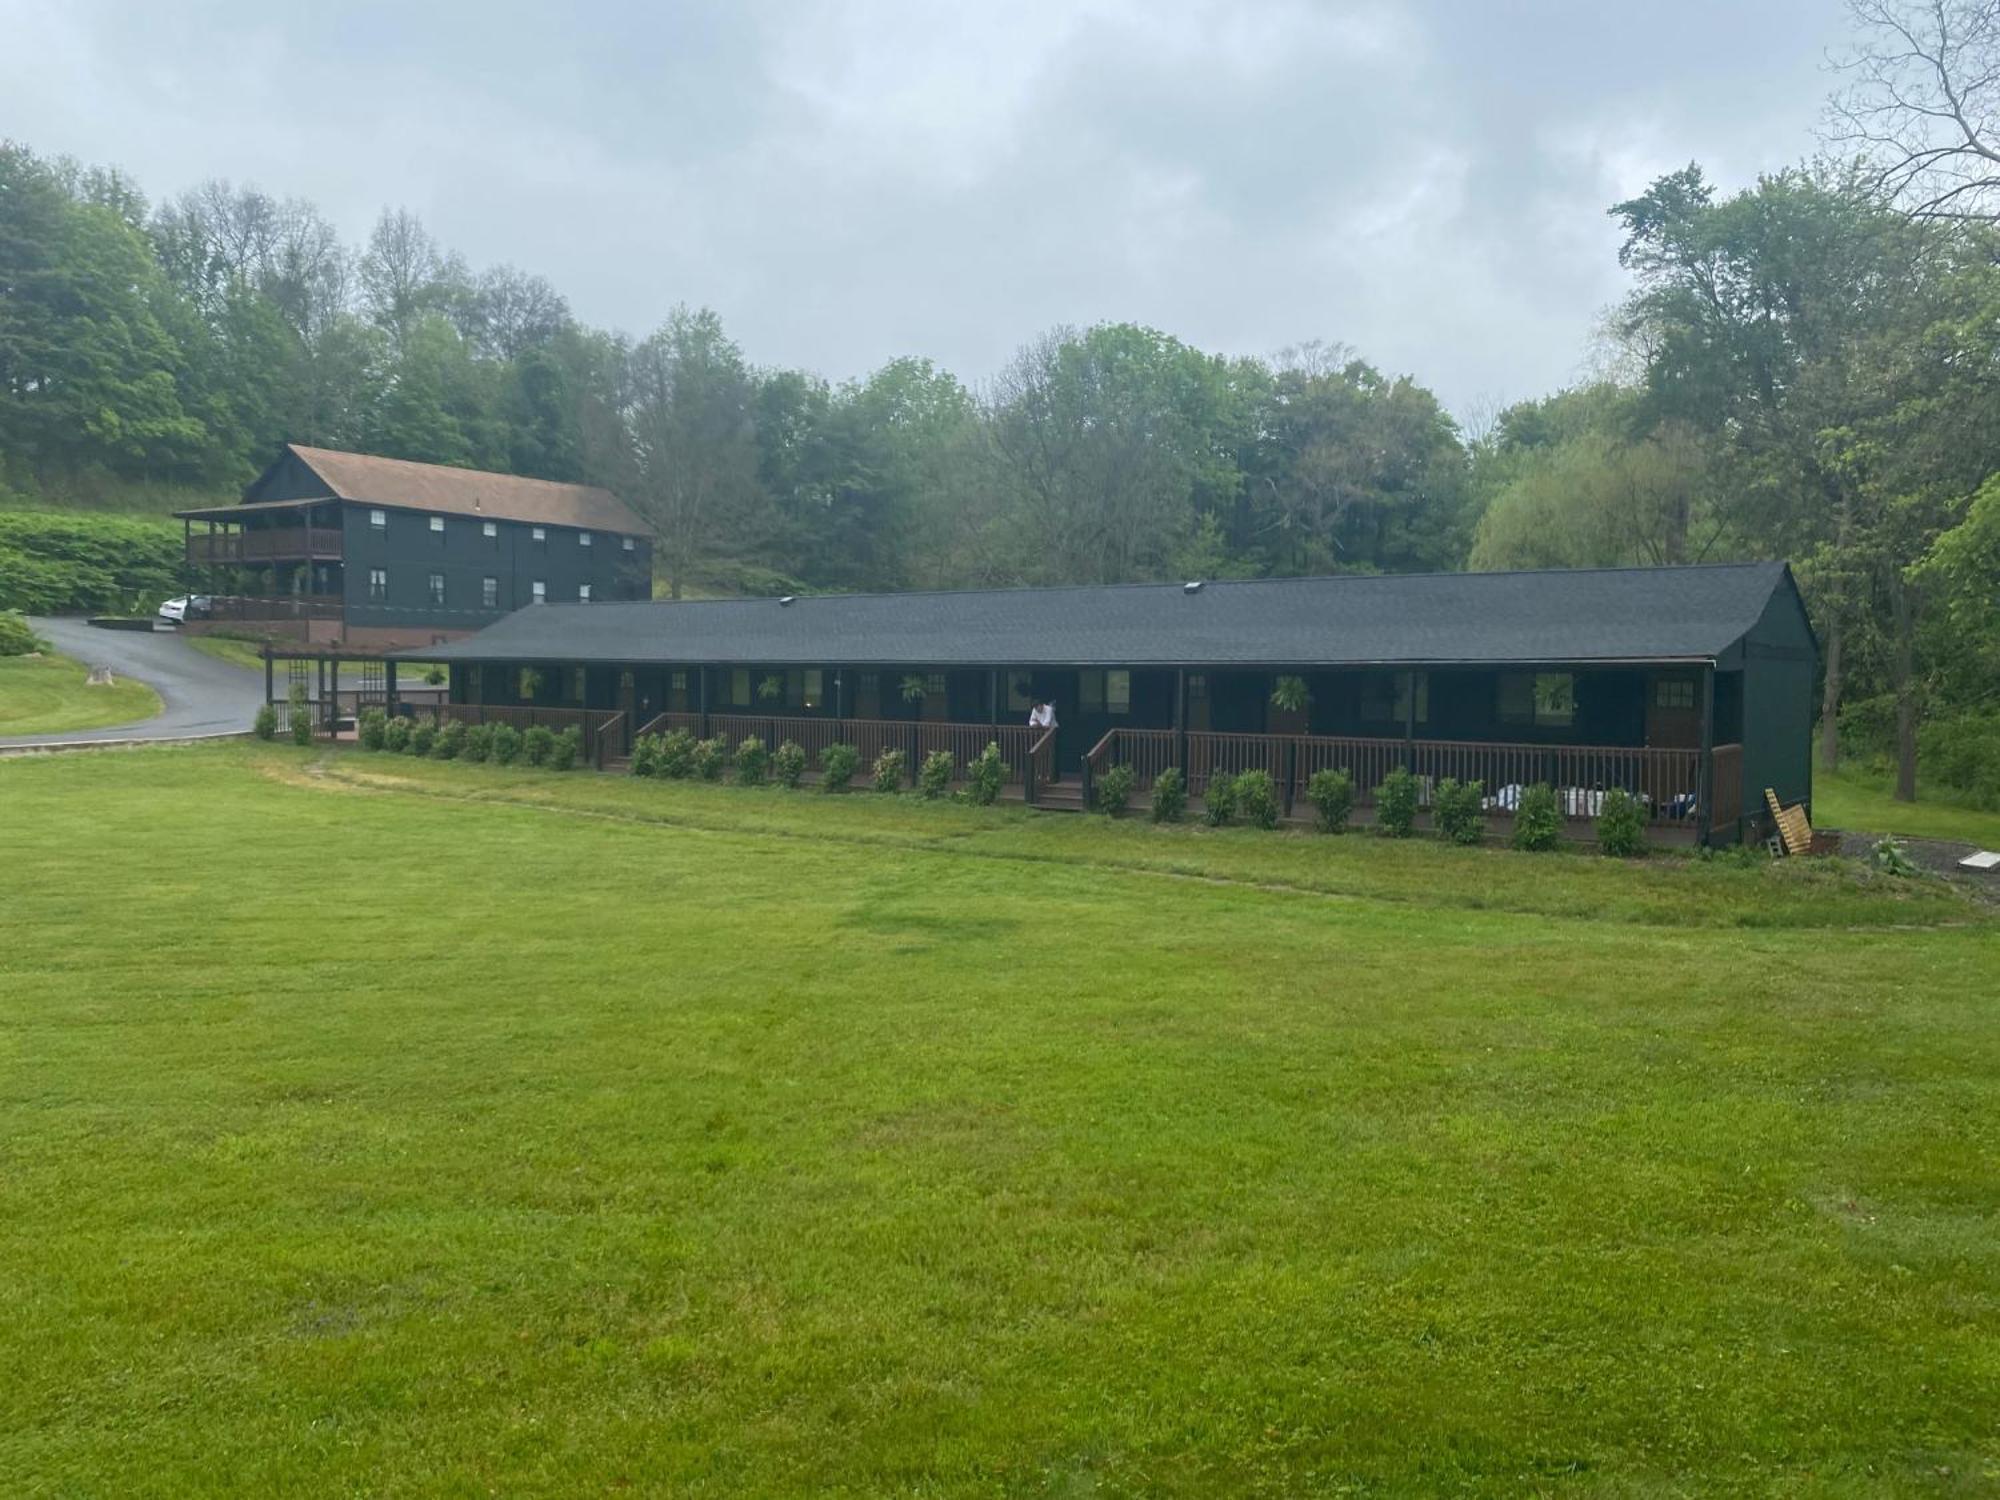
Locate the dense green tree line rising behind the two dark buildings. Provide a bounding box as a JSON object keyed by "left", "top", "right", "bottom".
{"left": 0, "top": 0, "right": 2000, "bottom": 804}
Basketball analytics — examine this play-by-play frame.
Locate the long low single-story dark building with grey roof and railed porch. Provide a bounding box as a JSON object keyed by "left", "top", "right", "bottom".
{"left": 406, "top": 562, "right": 1816, "bottom": 842}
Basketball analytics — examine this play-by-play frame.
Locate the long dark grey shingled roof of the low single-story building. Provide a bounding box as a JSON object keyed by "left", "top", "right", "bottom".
{"left": 412, "top": 562, "right": 1786, "bottom": 666}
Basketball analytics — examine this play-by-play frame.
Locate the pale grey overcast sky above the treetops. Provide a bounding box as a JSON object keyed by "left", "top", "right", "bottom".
{"left": 0, "top": 0, "right": 1844, "bottom": 412}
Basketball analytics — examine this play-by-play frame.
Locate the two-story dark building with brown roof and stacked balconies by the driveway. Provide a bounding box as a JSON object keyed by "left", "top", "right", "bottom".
{"left": 174, "top": 444, "right": 652, "bottom": 650}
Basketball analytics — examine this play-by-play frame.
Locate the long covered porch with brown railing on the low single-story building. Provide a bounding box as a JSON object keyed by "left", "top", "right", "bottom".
{"left": 444, "top": 662, "right": 1744, "bottom": 842}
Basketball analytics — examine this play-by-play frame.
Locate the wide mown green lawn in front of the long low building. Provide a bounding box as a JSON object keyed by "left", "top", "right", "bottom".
{"left": 0, "top": 744, "right": 2000, "bottom": 1496}
